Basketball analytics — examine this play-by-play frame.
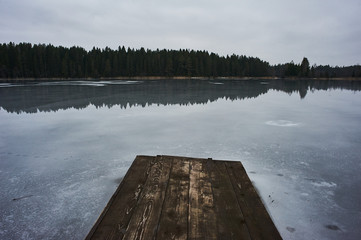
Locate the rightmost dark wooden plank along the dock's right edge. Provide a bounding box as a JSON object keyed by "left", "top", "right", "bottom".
{"left": 225, "top": 162, "right": 282, "bottom": 240}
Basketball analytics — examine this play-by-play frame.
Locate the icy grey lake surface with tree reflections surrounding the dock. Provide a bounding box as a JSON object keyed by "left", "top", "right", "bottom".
{"left": 0, "top": 80, "right": 361, "bottom": 239}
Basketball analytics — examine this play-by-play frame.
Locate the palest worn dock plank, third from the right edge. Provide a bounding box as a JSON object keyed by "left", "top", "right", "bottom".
{"left": 188, "top": 159, "right": 217, "bottom": 239}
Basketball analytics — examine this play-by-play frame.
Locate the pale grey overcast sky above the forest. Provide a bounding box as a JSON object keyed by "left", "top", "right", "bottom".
{"left": 0, "top": 0, "right": 361, "bottom": 66}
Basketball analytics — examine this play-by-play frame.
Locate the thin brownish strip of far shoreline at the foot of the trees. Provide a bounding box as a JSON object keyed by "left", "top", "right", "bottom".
{"left": 0, "top": 76, "right": 361, "bottom": 83}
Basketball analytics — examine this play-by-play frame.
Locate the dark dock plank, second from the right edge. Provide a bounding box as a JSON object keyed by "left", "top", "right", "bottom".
{"left": 208, "top": 161, "right": 251, "bottom": 240}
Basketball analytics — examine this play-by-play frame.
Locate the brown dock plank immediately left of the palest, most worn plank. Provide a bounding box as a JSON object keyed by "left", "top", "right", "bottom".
{"left": 157, "top": 157, "right": 189, "bottom": 240}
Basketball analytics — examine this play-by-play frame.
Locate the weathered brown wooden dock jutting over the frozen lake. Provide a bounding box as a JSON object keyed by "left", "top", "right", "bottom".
{"left": 86, "top": 156, "right": 282, "bottom": 240}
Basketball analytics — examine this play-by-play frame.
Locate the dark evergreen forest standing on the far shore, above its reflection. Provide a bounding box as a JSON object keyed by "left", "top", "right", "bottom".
{"left": 0, "top": 42, "right": 361, "bottom": 78}
